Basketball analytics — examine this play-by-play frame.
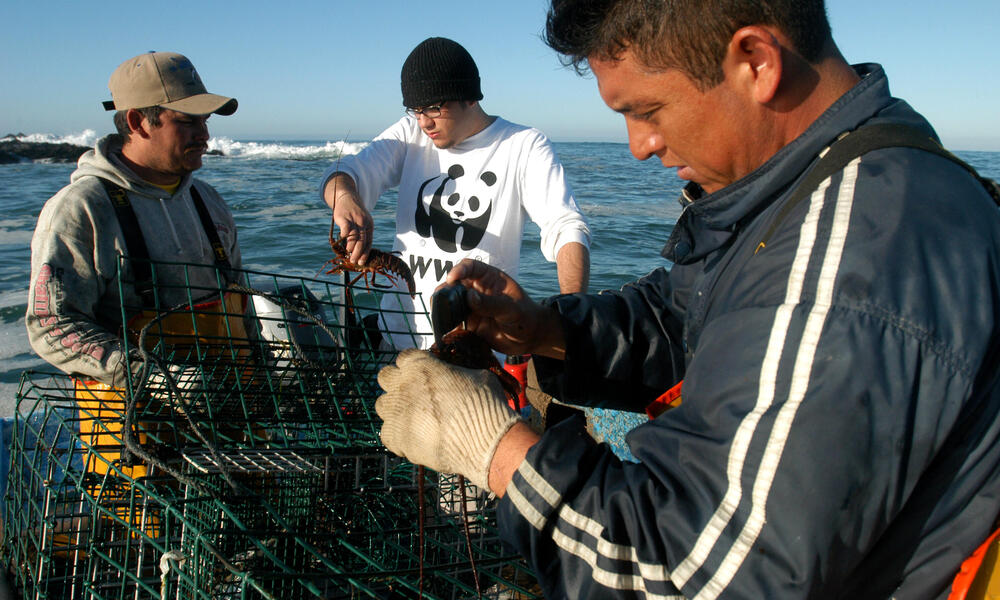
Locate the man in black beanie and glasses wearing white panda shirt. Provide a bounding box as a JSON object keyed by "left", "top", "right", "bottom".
{"left": 320, "top": 37, "right": 590, "bottom": 349}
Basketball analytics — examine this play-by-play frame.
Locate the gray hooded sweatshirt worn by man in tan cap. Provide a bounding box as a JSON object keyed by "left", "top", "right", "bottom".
{"left": 25, "top": 135, "right": 241, "bottom": 387}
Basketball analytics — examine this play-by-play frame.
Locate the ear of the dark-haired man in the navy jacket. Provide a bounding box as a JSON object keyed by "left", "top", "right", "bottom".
{"left": 723, "top": 25, "right": 784, "bottom": 104}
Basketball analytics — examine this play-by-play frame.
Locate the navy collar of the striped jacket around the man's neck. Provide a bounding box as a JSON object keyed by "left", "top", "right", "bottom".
{"left": 660, "top": 63, "right": 893, "bottom": 264}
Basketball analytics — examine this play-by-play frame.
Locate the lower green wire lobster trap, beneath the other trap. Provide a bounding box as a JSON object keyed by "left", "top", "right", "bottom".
{"left": 0, "top": 374, "right": 540, "bottom": 600}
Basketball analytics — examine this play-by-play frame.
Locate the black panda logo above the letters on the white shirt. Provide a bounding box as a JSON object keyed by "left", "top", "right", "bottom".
{"left": 414, "top": 165, "right": 497, "bottom": 252}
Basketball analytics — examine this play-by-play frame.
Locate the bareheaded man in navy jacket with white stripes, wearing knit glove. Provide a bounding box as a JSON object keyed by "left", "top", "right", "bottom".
{"left": 377, "top": 0, "right": 1000, "bottom": 600}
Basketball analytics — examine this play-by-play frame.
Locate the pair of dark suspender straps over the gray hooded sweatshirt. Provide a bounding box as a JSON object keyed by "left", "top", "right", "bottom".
{"left": 98, "top": 177, "right": 232, "bottom": 307}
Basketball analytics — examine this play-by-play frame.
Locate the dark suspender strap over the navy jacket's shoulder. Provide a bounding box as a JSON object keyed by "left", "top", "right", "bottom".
{"left": 754, "top": 123, "right": 1000, "bottom": 254}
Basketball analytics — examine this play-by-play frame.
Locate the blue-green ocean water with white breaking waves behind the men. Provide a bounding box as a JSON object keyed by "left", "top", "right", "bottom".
{"left": 0, "top": 130, "right": 1000, "bottom": 428}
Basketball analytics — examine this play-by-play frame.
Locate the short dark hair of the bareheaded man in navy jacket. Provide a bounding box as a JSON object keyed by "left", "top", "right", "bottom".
{"left": 545, "top": 0, "right": 831, "bottom": 90}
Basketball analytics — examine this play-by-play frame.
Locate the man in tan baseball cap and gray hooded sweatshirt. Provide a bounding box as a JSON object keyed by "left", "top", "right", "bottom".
{"left": 26, "top": 52, "right": 241, "bottom": 388}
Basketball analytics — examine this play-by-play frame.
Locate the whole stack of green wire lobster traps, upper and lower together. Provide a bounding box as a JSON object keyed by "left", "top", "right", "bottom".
{"left": 0, "top": 264, "right": 540, "bottom": 600}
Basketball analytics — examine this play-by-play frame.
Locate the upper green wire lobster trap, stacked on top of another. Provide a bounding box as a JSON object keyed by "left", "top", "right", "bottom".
{"left": 107, "top": 253, "right": 434, "bottom": 454}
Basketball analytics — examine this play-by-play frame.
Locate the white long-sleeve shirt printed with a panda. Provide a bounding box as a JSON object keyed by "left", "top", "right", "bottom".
{"left": 320, "top": 116, "right": 590, "bottom": 348}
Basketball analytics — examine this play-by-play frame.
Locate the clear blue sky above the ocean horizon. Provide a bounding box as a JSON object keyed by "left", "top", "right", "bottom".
{"left": 0, "top": 0, "right": 1000, "bottom": 150}
